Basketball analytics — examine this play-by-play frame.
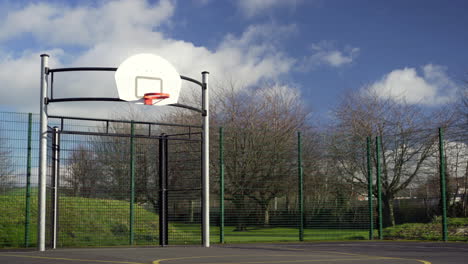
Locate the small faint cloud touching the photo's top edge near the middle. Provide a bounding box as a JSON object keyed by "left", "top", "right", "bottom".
{"left": 237, "top": 0, "right": 298, "bottom": 18}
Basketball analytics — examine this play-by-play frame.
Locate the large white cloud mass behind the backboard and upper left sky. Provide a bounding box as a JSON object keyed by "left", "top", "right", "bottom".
{"left": 0, "top": 0, "right": 296, "bottom": 116}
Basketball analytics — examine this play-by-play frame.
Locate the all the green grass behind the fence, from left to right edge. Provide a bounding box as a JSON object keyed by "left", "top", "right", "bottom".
{"left": 7, "top": 189, "right": 468, "bottom": 247}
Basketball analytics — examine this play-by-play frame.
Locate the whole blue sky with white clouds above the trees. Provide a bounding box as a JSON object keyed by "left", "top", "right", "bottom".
{"left": 0, "top": 0, "right": 468, "bottom": 119}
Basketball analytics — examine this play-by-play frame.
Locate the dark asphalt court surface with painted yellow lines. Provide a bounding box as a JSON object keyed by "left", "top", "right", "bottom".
{"left": 0, "top": 241, "right": 468, "bottom": 264}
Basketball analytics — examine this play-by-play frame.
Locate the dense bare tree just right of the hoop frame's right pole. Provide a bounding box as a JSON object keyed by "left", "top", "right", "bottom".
{"left": 213, "top": 83, "right": 308, "bottom": 231}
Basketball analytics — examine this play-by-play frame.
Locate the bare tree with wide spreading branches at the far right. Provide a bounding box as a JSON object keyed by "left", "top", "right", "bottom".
{"left": 332, "top": 90, "right": 448, "bottom": 225}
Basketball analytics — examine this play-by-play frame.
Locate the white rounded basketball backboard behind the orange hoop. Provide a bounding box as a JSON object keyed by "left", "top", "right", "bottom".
{"left": 115, "top": 53, "right": 182, "bottom": 105}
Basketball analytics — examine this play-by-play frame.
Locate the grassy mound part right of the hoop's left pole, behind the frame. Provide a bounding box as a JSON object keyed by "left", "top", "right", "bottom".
{"left": 58, "top": 197, "right": 163, "bottom": 246}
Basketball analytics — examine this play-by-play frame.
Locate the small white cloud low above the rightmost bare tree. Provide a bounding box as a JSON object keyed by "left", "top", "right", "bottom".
{"left": 369, "top": 64, "right": 457, "bottom": 105}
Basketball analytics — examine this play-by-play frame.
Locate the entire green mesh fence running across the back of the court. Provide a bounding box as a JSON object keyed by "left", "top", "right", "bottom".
{"left": 0, "top": 113, "right": 468, "bottom": 247}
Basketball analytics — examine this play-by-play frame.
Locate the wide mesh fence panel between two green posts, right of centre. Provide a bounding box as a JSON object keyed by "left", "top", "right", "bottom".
{"left": 304, "top": 135, "right": 375, "bottom": 240}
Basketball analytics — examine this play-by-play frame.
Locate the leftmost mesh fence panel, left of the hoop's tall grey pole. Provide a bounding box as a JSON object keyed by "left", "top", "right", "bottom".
{"left": 0, "top": 112, "right": 39, "bottom": 247}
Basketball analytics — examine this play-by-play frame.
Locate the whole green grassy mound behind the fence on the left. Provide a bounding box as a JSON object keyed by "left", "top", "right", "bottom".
{"left": 0, "top": 189, "right": 192, "bottom": 247}
